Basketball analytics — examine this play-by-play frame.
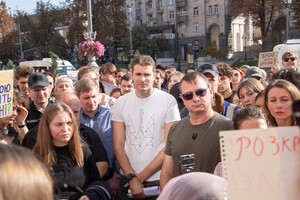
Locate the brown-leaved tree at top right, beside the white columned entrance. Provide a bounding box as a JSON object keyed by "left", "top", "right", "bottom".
{"left": 228, "top": 0, "right": 285, "bottom": 51}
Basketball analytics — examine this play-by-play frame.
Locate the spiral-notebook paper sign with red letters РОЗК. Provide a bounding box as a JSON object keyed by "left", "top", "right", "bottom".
{"left": 220, "top": 126, "right": 300, "bottom": 200}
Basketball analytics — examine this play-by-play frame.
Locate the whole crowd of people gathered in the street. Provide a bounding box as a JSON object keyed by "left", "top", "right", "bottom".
{"left": 0, "top": 52, "right": 300, "bottom": 200}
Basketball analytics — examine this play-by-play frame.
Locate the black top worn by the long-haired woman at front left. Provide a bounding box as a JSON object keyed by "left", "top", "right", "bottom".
{"left": 50, "top": 145, "right": 103, "bottom": 199}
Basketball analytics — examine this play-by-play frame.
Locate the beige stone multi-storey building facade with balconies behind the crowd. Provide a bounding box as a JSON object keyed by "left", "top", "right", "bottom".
{"left": 126, "top": 0, "right": 236, "bottom": 60}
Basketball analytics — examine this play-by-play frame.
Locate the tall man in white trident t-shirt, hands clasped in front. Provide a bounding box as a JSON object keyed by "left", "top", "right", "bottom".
{"left": 112, "top": 56, "right": 180, "bottom": 199}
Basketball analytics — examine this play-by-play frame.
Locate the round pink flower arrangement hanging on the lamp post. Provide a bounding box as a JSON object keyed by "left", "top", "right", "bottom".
{"left": 78, "top": 41, "right": 104, "bottom": 60}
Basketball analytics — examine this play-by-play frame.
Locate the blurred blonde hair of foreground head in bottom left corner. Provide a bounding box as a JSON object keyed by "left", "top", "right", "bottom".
{"left": 0, "top": 144, "right": 53, "bottom": 200}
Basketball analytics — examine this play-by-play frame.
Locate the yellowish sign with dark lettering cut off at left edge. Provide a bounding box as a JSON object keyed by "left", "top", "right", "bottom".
{"left": 0, "top": 70, "right": 14, "bottom": 117}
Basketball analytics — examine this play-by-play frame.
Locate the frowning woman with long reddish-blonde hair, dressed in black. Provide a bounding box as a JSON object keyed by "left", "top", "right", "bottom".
{"left": 33, "top": 103, "right": 109, "bottom": 200}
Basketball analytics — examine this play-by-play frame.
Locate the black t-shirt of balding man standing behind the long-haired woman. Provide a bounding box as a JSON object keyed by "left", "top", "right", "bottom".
{"left": 22, "top": 124, "right": 108, "bottom": 162}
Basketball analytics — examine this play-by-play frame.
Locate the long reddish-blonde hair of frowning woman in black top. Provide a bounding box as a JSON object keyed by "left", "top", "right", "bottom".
{"left": 33, "top": 102, "right": 84, "bottom": 169}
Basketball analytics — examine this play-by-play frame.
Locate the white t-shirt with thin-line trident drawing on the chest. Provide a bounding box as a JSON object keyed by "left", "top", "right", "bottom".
{"left": 112, "top": 89, "right": 180, "bottom": 181}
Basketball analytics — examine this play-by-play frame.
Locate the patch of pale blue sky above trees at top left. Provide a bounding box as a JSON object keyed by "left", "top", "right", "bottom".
{"left": 1, "top": 0, "right": 62, "bottom": 14}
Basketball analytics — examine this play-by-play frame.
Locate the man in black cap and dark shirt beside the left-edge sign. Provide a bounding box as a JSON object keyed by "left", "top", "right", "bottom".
{"left": 25, "top": 72, "right": 49, "bottom": 130}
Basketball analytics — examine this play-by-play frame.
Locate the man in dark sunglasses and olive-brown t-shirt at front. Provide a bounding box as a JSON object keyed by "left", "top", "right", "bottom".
{"left": 160, "top": 72, "right": 233, "bottom": 189}
